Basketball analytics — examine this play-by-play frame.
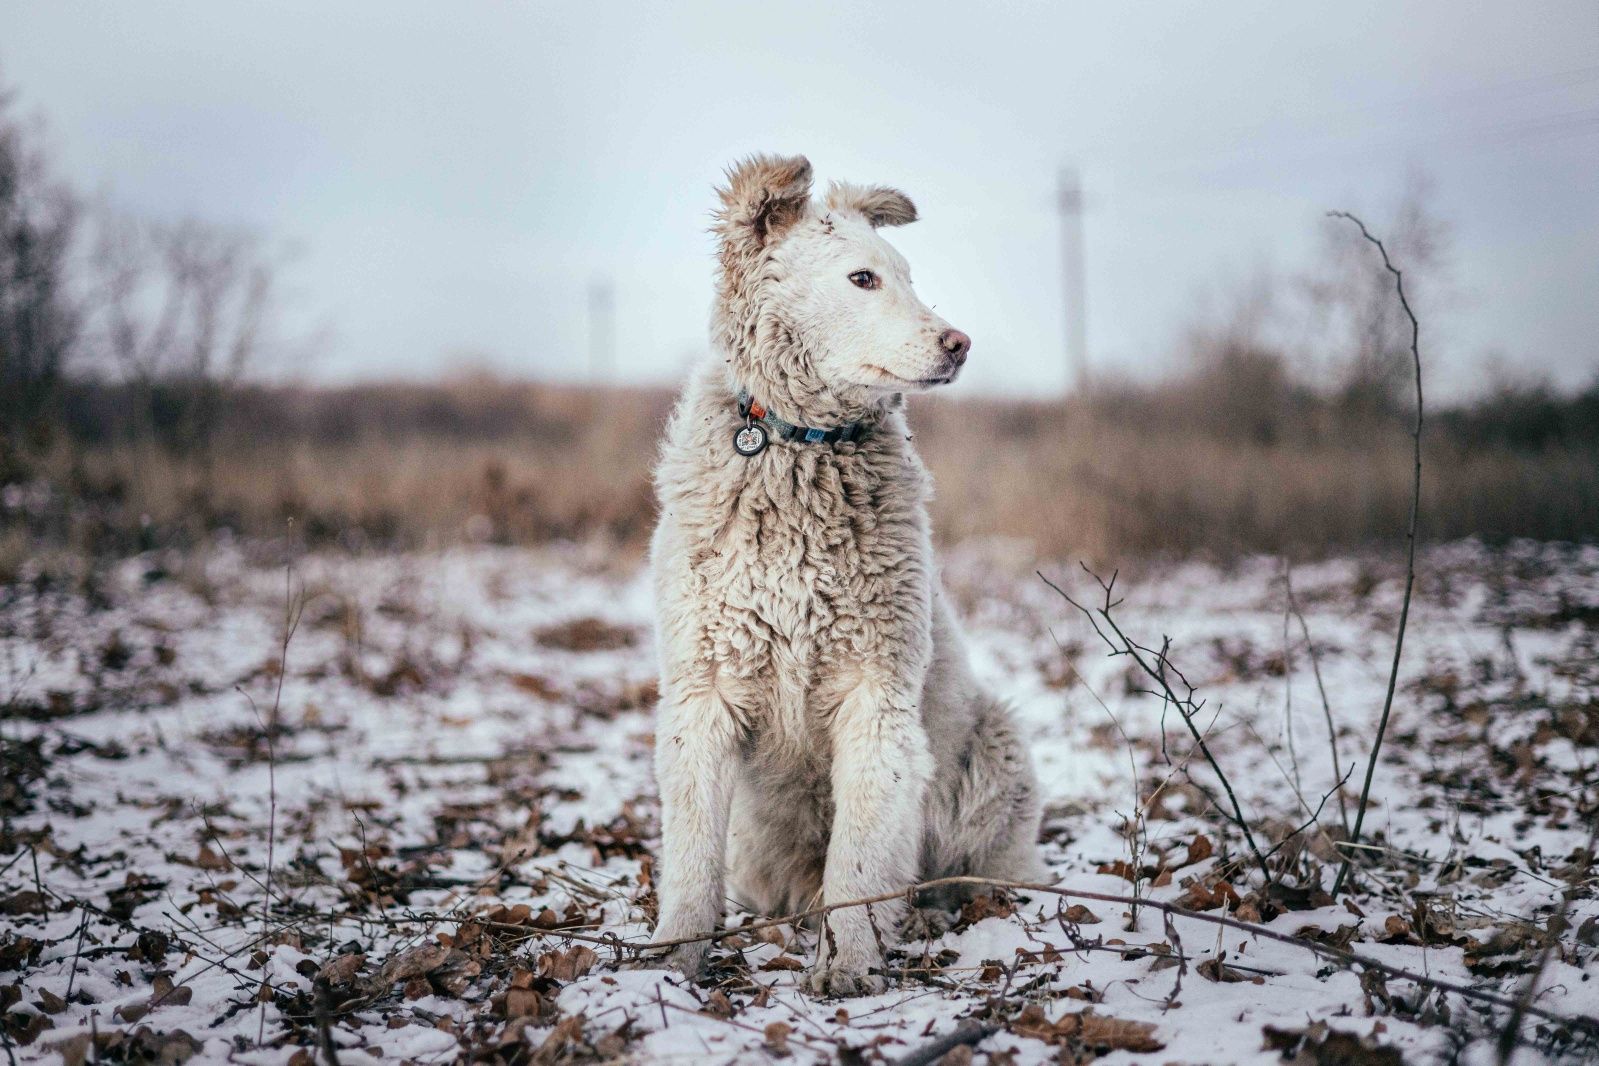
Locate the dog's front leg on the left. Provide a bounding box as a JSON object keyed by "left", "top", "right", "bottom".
{"left": 654, "top": 694, "right": 739, "bottom": 977}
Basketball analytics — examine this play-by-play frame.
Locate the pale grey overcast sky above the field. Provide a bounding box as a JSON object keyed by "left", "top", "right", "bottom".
{"left": 0, "top": 0, "right": 1599, "bottom": 393}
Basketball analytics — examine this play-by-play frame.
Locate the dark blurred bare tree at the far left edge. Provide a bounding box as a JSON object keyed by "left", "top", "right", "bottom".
{"left": 0, "top": 81, "right": 78, "bottom": 463}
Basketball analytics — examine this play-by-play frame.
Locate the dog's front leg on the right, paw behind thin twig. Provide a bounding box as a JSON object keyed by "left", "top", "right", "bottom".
{"left": 811, "top": 684, "right": 932, "bottom": 996}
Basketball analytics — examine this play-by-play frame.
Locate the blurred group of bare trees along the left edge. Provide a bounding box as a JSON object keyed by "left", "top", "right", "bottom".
{"left": 0, "top": 75, "right": 275, "bottom": 483}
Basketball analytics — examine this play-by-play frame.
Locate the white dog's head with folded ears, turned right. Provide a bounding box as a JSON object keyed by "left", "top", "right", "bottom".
{"left": 716, "top": 155, "right": 972, "bottom": 417}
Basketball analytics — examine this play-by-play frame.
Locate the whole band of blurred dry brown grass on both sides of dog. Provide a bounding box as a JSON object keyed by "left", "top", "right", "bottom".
{"left": 15, "top": 380, "right": 1599, "bottom": 559}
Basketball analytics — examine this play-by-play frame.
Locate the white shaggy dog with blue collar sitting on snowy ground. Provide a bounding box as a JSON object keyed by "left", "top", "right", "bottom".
{"left": 651, "top": 157, "right": 1039, "bottom": 996}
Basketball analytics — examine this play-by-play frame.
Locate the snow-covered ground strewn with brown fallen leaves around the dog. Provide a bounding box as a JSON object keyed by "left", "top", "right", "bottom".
{"left": 0, "top": 543, "right": 1599, "bottom": 1066}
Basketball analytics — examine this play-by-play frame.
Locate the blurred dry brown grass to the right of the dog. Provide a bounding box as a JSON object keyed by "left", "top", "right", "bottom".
{"left": 916, "top": 403, "right": 1599, "bottom": 559}
